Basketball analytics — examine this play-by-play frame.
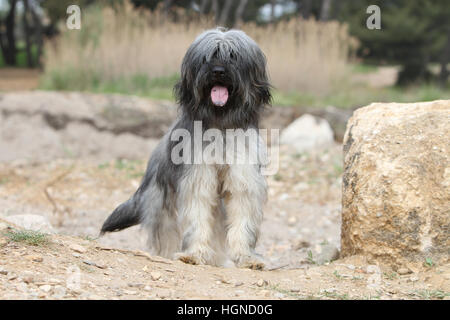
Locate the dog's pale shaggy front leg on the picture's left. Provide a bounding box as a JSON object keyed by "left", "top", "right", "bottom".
{"left": 175, "top": 164, "right": 218, "bottom": 264}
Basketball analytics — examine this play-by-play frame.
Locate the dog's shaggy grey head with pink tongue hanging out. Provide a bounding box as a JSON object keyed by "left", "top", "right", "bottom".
{"left": 175, "top": 29, "right": 271, "bottom": 126}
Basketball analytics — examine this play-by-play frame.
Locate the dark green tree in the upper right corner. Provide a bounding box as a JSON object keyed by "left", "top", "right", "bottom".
{"left": 339, "top": 0, "right": 450, "bottom": 85}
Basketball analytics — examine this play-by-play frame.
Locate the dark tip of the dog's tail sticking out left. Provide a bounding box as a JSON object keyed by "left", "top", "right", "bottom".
{"left": 100, "top": 196, "right": 142, "bottom": 236}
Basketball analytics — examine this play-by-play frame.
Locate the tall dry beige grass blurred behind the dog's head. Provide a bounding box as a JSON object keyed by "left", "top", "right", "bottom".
{"left": 44, "top": 4, "right": 353, "bottom": 94}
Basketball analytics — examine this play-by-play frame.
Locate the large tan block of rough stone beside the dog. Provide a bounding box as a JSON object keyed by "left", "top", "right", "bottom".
{"left": 341, "top": 100, "right": 450, "bottom": 268}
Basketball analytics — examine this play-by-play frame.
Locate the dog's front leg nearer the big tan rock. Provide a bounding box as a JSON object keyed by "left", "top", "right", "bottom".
{"left": 224, "top": 164, "right": 267, "bottom": 269}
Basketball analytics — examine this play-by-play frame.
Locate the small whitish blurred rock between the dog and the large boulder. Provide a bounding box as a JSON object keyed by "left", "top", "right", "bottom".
{"left": 280, "top": 114, "right": 334, "bottom": 153}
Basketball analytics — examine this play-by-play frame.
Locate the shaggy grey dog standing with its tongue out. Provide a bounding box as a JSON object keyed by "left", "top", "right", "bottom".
{"left": 101, "top": 29, "right": 271, "bottom": 269}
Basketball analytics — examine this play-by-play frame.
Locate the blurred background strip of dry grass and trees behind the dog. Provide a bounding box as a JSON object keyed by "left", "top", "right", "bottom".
{"left": 0, "top": 0, "right": 450, "bottom": 109}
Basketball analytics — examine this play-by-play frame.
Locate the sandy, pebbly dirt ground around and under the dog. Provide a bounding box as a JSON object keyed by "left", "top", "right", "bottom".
{"left": 0, "top": 89, "right": 450, "bottom": 299}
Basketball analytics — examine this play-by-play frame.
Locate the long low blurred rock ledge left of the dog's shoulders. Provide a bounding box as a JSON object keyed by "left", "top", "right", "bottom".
{"left": 0, "top": 91, "right": 177, "bottom": 163}
